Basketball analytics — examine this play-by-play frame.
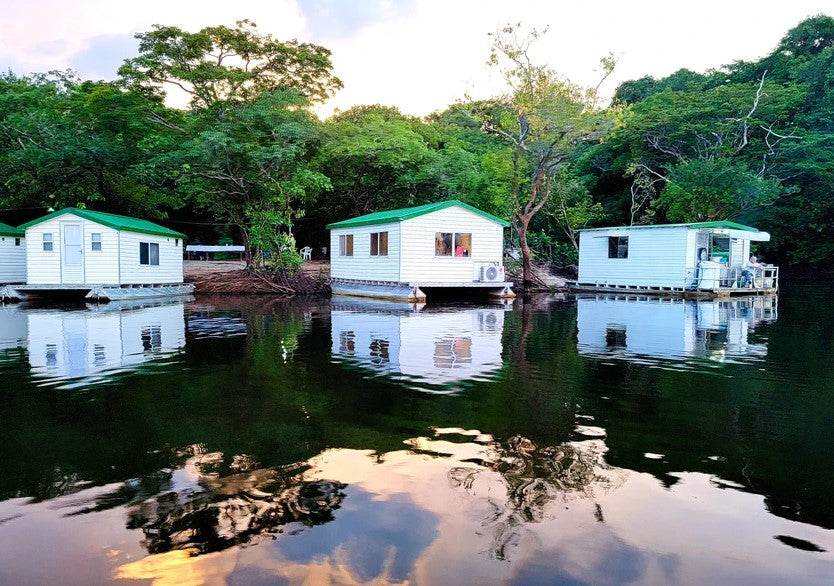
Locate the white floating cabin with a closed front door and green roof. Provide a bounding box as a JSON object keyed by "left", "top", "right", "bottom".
{"left": 0, "top": 208, "right": 193, "bottom": 300}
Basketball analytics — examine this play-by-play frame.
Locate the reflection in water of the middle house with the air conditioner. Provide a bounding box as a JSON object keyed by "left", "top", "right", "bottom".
{"left": 330, "top": 298, "right": 505, "bottom": 384}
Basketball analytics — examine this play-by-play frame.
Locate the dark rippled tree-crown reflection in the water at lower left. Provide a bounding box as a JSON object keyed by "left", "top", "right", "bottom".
{"left": 70, "top": 448, "right": 346, "bottom": 554}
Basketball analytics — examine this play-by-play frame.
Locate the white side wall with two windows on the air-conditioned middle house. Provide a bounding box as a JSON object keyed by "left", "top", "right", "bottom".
{"left": 330, "top": 223, "right": 400, "bottom": 281}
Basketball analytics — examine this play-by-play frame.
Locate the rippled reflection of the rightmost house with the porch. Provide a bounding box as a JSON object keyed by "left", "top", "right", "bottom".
{"left": 576, "top": 295, "right": 777, "bottom": 359}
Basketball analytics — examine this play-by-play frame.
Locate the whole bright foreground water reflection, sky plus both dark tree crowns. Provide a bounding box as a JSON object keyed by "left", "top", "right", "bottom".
{"left": 0, "top": 428, "right": 834, "bottom": 584}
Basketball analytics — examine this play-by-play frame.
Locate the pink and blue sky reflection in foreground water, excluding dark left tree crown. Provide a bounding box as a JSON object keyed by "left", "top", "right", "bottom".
{"left": 0, "top": 430, "right": 834, "bottom": 585}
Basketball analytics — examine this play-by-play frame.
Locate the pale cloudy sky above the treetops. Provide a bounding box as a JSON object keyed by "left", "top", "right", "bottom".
{"left": 0, "top": 0, "right": 834, "bottom": 116}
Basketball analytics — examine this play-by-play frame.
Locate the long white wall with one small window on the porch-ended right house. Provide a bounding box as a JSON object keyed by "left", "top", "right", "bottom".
{"left": 577, "top": 226, "right": 692, "bottom": 287}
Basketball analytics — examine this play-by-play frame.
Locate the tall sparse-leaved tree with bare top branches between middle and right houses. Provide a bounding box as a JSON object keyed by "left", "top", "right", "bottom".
{"left": 478, "top": 25, "right": 614, "bottom": 287}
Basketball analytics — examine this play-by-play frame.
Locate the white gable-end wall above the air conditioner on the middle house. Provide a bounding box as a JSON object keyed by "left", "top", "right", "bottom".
{"left": 400, "top": 207, "right": 504, "bottom": 283}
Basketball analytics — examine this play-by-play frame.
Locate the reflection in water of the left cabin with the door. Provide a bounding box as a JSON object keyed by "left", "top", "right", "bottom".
{"left": 26, "top": 303, "right": 185, "bottom": 382}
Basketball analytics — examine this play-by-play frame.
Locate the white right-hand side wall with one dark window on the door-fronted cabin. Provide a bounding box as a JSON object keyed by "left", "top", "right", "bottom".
{"left": 119, "top": 231, "right": 183, "bottom": 285}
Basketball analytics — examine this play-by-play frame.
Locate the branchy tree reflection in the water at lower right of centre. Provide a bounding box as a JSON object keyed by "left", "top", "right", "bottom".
{"left": 449, "top": 436, "right": 620, "bottom": 560}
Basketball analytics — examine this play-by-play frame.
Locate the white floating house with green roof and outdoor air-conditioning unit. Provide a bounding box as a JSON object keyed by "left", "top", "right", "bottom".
{"left": 327, "top": 200, "right": 514, "bottom": 302}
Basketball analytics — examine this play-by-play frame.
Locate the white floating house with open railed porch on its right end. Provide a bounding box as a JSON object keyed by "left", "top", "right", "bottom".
{"left": 576, "top": 221, "right": 779, "bottom": 296}
